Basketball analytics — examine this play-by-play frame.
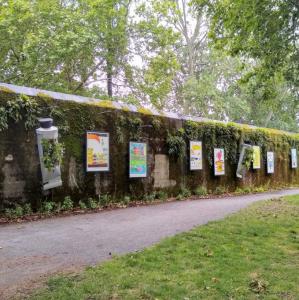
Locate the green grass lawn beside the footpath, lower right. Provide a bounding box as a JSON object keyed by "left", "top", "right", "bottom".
{"left": 33, "top": 196, "right": 299, "bottom": 300}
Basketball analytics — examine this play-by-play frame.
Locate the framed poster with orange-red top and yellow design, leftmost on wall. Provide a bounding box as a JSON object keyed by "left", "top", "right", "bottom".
{"left": 86, "top": 131, "right": 109, "bottom": 172}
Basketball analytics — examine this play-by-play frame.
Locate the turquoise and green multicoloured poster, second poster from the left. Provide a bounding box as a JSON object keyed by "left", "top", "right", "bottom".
{"left": 130, "top": 142, "right": 147, "bottom": 178}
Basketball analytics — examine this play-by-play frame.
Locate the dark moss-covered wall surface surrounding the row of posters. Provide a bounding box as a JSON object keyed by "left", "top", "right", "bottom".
{"left": 0, "top": 89, "right": 299, "bottom": 208}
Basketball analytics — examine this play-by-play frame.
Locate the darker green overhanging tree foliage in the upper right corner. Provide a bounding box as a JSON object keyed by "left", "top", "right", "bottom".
{"left": 207, "top": 0, "right": 299, "bottom": 92}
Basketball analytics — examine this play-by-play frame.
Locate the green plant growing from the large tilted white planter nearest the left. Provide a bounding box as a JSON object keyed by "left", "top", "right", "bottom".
{"left": 42, "top": 139, "right": 64, "bottom": 171}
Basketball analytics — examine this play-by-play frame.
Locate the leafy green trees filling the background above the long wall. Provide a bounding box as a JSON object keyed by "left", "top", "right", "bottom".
{"left": 0, "top": 0, "right": 299, "bottom": 130}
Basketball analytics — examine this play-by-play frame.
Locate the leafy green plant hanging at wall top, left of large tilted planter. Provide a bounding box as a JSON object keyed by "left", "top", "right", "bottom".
{"left": 0, "top": 95, "right": 40, "bottom": 131}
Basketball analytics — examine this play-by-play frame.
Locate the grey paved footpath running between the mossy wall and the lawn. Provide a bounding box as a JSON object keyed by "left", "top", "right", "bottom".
{"left": 0, "top": 189, "right": 299, "bottom": 299}
